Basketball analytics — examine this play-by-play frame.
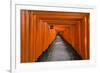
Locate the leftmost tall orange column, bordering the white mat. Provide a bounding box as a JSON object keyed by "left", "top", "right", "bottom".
{"left": 21, "top": 10, "right": 29, "bottom": 63}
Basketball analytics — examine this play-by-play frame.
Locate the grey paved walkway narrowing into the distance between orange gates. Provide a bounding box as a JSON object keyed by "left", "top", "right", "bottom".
{"left": 38, "top": 35, "right": 81, "bottom": 62}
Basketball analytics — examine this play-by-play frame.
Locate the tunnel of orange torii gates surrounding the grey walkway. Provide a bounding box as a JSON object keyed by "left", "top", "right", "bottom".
{"left": 21, "top": 10, "right": 90, "bottom": 63}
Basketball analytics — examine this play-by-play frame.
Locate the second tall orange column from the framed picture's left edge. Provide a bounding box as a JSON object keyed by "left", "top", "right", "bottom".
{"left": 28, "top": 11, "right": 37, "bottom": 62}
